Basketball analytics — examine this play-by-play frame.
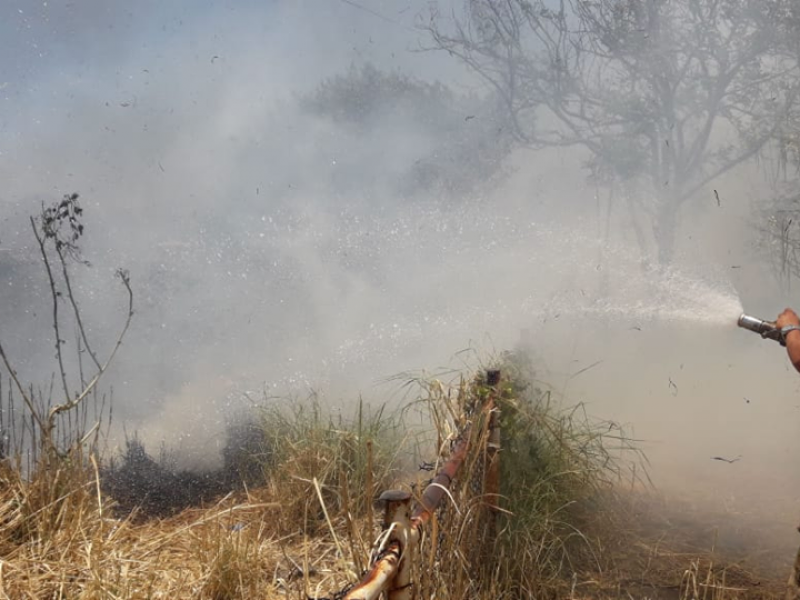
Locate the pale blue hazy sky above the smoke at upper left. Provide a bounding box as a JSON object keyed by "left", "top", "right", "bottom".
{"left": 0, "top": 0, "right": 456, "bottom": 206}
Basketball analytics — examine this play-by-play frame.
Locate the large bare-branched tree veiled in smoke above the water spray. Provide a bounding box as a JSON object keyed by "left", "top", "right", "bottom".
{"left": 421, "top": 0, "right": 800, "bottom": 264}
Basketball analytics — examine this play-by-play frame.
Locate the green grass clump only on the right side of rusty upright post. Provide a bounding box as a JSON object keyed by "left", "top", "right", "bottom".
{"left": 497, "top": 355, "right": 646, "bottom": 594}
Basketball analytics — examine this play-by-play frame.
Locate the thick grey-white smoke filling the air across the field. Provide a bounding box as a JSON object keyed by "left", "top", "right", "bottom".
{"left": 0, "top": 0, "right": 800, "bottom": 548}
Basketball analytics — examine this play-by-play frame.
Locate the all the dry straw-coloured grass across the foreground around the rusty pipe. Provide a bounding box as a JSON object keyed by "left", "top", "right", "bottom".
{"left": 0, "top": 364, "right": 782, "bottom": 600}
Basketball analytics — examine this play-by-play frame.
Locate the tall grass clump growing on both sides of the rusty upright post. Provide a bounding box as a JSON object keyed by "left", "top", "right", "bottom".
{"left": 406, "top": 354, "right": 642, "bottom": 598}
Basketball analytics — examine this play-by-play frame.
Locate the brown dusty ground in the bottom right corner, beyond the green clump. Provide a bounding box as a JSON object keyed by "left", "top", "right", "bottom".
{"left": 580, "top": 494, "right": 800, "bottom": 600}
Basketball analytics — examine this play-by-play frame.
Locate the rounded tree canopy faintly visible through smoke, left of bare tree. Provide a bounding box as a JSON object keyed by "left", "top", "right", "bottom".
{"left": 299, "top": 63, "right": 511, "bottom": 198}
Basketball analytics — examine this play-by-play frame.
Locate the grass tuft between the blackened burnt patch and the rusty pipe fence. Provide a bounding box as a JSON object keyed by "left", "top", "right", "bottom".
{"left": 260, "top": 396, "right": 405, "bottom": 547}
